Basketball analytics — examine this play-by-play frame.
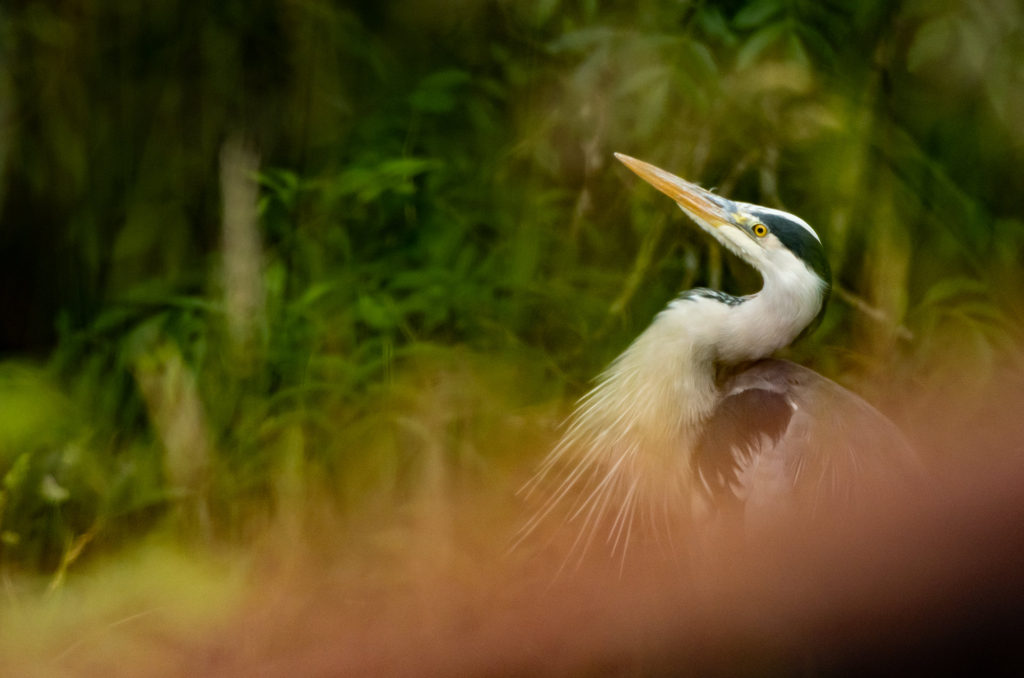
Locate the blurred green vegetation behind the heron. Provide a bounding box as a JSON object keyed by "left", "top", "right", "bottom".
{"left": 0, "top": 0, "right": 1024, "bottom": 586}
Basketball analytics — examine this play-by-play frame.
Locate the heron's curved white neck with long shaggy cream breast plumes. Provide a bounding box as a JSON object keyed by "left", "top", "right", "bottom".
{"left": 526, "top": 270, "right": 827, "bottom": 545}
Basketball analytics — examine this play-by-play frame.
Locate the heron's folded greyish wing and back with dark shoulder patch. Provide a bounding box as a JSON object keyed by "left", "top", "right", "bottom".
{"left": 693, "top": 359, "right": 922, "bottom": 513}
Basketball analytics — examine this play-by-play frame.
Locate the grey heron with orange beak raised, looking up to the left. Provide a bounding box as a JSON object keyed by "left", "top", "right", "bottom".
{"left": 527, "top": 154, "right": 918, "bottom": 545}
